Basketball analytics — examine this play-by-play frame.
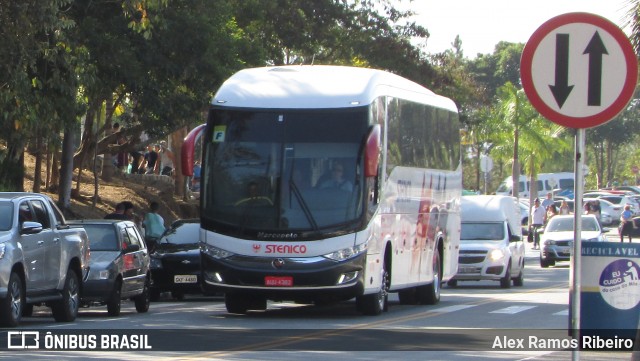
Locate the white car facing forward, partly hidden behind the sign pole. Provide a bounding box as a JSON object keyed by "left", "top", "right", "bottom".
{"left": 540, "top": 214, "right": 608, "bottom": 268}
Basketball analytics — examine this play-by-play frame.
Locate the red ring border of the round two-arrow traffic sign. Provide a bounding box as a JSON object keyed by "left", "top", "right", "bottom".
{"left": 520, "top": 13, "right": 638, "bottom": 128}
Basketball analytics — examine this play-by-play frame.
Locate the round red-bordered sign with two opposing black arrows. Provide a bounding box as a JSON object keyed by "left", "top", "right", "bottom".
{"left": 520, "top": 13, "right": 638, "bottom": 128}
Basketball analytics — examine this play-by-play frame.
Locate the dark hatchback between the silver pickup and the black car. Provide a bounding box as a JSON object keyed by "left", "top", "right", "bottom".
{"left": 68, "top": 219, "right": 151, "bottom": 316}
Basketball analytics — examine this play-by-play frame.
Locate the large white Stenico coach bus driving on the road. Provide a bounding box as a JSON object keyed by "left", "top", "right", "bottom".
{"left": 190, "top": 66, "right": 462, "bottom": 315}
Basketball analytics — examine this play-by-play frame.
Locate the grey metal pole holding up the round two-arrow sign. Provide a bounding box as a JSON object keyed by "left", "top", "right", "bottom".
{"left": 570, "top": 128, "right": 586, "bottom": 361}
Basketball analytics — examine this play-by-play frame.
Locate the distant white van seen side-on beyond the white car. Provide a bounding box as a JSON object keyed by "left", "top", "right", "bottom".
{"left": 496, "top": 172, "right": 575, "bottom": 198}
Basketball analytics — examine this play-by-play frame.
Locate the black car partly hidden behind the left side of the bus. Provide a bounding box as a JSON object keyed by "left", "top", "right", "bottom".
{"left": 151, "top": 219, "right": 202, "bottom": 300}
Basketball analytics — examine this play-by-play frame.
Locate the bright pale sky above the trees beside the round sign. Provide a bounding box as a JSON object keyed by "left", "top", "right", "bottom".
{"left": 399, "top": 0, "right": 629, "bottom": 58}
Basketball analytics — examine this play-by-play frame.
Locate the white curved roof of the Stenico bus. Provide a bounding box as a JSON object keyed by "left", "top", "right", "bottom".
{"left": 212, "top": 65, "right": 457, "bottom": 112}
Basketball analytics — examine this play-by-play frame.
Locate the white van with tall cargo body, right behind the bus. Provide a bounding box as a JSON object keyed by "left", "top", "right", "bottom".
{"left": 448, "top": 195, "right": 525, "bottom": 288}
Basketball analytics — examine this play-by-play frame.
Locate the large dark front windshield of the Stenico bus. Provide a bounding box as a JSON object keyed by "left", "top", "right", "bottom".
{"left": 201, "top": 107, "right": 369, "bottom": 237}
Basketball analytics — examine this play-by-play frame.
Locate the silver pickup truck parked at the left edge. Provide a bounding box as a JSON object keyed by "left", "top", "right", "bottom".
{"left": 0, "top": 192, "right": 90, "bottom": 327}
